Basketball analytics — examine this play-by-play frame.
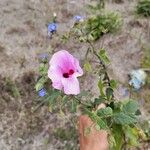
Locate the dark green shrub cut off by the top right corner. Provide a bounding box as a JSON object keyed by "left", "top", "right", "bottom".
{"left": 136, "top": 0, "right": 150, "bottom": 17}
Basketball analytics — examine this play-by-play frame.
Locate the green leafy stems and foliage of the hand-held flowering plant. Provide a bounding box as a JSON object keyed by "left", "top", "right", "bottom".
{"left": 36, "top": 27, "right": 144, "bottom": 150}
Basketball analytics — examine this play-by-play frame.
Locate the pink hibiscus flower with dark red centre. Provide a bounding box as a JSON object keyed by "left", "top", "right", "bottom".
{"left": 48, "top": 50, "right": 83, "bottom": 95}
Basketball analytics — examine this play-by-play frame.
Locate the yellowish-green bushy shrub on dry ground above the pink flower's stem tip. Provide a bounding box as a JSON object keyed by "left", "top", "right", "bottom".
{"left": 81, "top": 12, "right": 122, "bottom": 41}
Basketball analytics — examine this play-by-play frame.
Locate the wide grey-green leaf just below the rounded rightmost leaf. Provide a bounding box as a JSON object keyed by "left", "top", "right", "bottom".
{"left": 113, "top": 112, "right": 137, "bottom": 125}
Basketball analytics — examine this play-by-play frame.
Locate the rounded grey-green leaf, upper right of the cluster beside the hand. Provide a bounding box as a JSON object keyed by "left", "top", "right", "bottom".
{"left": 122, "top": 100, "right": 139, "bottom": 114}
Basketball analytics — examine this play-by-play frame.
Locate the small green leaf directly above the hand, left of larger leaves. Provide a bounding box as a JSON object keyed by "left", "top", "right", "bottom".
{"left": 97, "top": 107, "right": 113, "bottom": 117}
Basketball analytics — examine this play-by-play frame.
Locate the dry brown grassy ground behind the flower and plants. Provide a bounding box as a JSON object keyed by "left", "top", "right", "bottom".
{"left": 0, "top": 0, "right": 150, "bottom": 150}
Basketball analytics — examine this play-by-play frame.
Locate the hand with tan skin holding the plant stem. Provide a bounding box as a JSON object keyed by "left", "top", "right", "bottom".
{"left": 79, "top": 105, "right": 108, "bottom": 150}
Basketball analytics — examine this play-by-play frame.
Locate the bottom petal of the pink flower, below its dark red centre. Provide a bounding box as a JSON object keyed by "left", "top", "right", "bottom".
{"left": 62, "top": 76, "right": 80, "bottom": 95}
